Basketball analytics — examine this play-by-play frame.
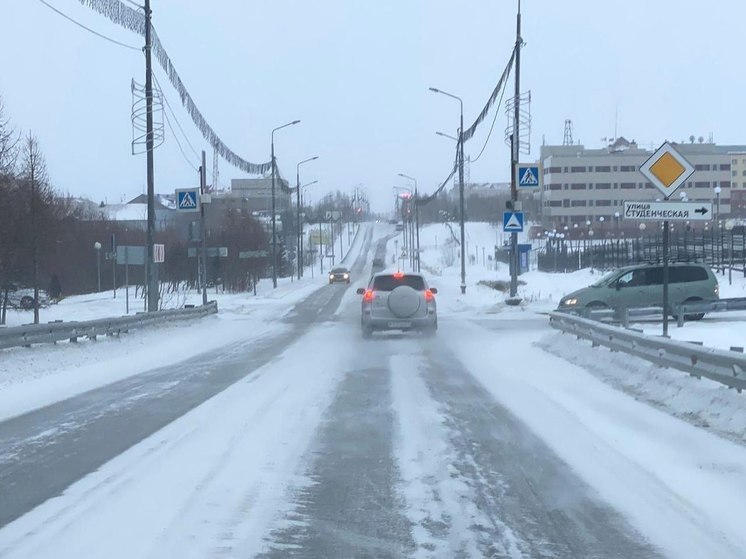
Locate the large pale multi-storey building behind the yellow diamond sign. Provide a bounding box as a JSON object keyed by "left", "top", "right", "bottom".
{"left": 540, "top": 138, "right": 746, "bottom": 227}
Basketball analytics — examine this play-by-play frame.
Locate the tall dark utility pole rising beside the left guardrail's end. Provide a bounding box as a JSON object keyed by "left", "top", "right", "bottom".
{"left": 145, "top": 0, "right": 158, "bottom": 312}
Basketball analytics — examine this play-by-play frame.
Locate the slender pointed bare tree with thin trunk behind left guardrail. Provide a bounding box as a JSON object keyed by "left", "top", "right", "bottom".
{"left": 21, "top": 131, "right": 51, "bottom": 324}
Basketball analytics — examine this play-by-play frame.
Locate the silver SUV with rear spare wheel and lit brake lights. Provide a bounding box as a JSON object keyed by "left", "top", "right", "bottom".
{"left": 357, "top": 272, "right": 438, "bottom": 338}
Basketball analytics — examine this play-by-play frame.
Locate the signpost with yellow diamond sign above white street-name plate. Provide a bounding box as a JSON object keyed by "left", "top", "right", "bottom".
{"left": 636, "top": 142, "right": 696, "bottom": 338}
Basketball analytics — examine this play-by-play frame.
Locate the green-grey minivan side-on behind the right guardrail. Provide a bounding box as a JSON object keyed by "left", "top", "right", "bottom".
{"left": 558, "top": 263, "right": 720, "bottom": 320}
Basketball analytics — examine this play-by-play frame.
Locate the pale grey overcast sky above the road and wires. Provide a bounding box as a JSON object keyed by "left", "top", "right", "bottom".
{"left": 0, "top": 0, "right": 746, "bottom": 210}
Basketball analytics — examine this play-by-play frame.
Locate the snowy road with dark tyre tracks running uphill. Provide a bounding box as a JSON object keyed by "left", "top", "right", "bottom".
{"left": 0, "top": 224, "right": 746, "bottom": 559}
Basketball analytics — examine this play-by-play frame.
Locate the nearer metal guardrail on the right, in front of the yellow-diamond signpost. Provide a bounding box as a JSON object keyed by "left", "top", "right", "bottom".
{"left": 549, "top": 312, "right": 746, "bottom": 392}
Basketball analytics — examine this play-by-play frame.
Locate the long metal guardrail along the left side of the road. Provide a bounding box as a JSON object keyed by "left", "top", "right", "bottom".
{"left": 0, "top": 301, "right": 218, "bottom": 349}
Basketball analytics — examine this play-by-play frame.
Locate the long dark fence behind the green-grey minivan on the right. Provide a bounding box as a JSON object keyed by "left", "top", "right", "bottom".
{"left": 537, "top": 227, "right": 746, "bottom": 276}
